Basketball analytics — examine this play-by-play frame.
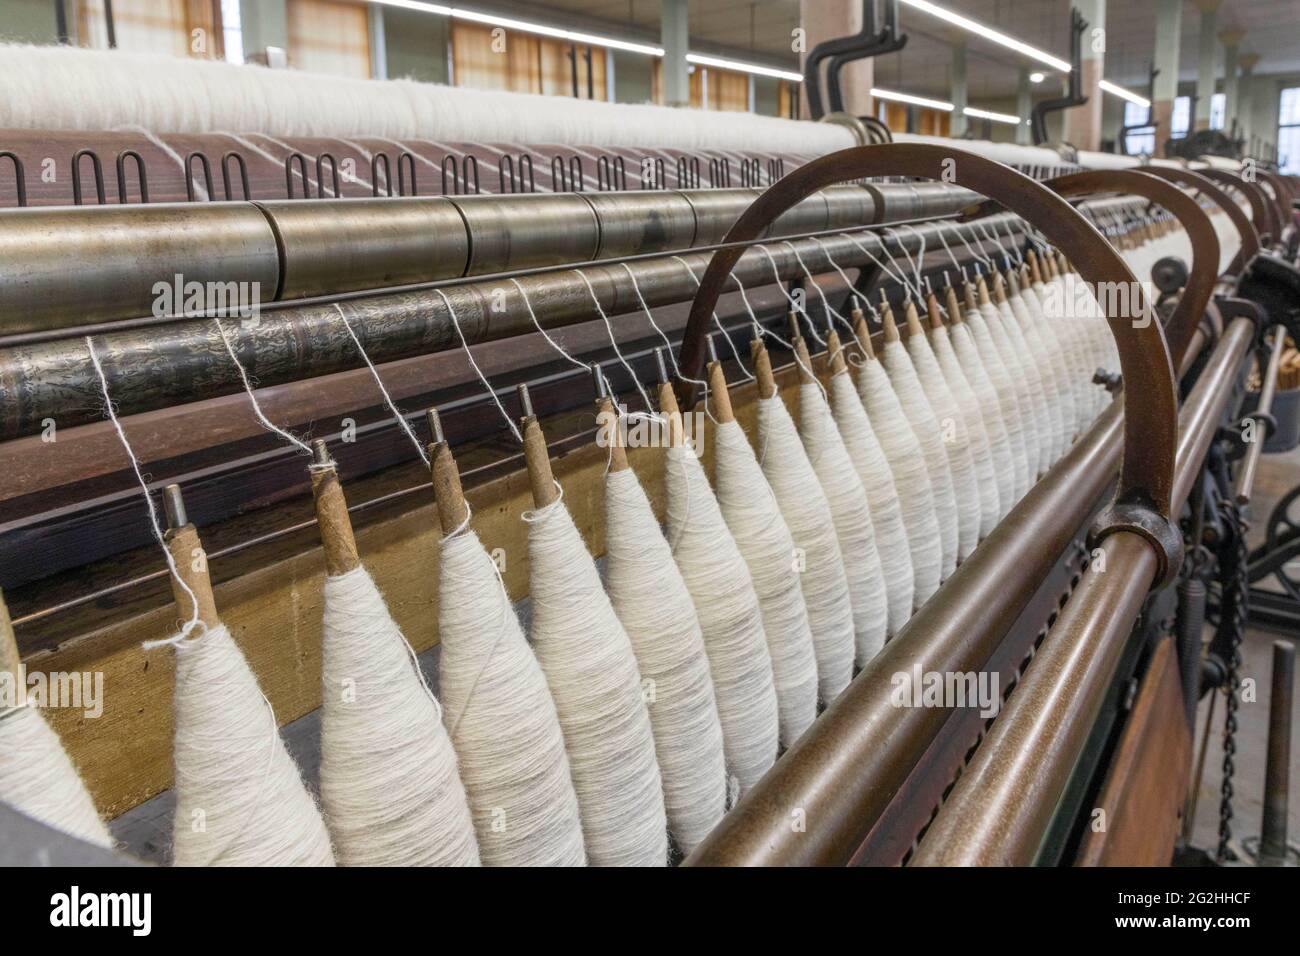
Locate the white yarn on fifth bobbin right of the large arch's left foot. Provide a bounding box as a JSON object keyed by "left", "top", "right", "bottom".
{"left": 858, "top": 356, "right": 944, "bottom": 600}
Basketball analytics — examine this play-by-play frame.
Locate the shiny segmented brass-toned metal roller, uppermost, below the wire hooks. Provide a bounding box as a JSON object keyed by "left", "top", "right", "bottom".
{"left": 0, "top": 185, "right": 883, "bottom": 333}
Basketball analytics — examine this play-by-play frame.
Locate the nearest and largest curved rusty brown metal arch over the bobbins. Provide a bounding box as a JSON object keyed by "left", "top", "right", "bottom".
{"left": 677, "top": 143, "right": 1178, "bottom": 568}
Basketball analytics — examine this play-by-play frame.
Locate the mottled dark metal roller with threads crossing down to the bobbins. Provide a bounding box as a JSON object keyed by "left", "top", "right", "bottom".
{"left": 0, "top": 210, "right": 1029, "bottom": 441}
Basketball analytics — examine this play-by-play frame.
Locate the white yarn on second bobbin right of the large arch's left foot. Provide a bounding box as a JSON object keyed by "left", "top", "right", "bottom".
{"left": 758, "top": 394, "right": 857, "bottom": 704}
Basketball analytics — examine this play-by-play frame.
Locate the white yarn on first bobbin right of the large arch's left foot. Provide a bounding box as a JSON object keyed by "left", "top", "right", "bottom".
{"left": 714, "top": 421, "right": 818, "bottom": 747}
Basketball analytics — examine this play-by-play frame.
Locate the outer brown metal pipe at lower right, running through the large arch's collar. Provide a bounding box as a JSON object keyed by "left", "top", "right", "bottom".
{"left": 913, "top": 319, "right": 1255, "bottom": 866}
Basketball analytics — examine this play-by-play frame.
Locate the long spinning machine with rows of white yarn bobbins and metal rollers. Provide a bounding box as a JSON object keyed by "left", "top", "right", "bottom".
{"left": 0, "top": 42, "right": 1300, "bottom": 865}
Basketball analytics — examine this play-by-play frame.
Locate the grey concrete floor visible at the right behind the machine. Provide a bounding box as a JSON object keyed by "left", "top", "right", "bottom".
{"left": 1192, "top": 439, "right": 1300, "bottom": 849}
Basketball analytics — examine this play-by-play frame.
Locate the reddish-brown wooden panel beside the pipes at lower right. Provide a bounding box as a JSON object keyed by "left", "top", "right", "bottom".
{"left": 1076, "top": 637, "right": 1192, "bottom": 866}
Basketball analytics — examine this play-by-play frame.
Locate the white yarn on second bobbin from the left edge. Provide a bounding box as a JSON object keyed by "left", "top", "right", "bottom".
{"left": 172, "top": 624, "right": 334, "bottom": 866}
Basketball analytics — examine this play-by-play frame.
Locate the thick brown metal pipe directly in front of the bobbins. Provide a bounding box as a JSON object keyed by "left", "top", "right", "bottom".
{"left": 685, "top": 399, "right": 1123, "bottom": 866}
